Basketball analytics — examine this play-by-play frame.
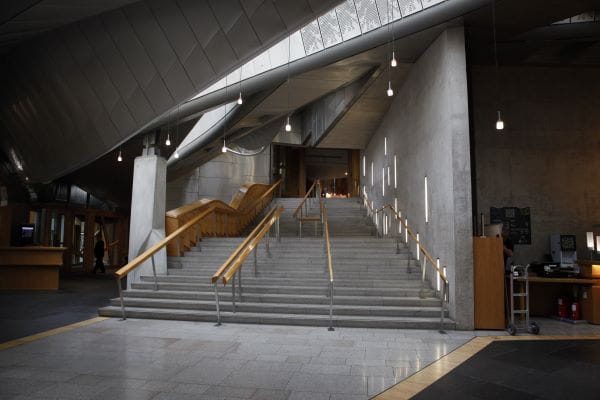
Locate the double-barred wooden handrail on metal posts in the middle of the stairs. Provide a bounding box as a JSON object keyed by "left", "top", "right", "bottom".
{"left": 211, "top": 206, "right": 283, "bottom": 326}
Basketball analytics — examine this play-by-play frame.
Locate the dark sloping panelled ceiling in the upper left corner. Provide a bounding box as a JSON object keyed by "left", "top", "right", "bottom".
{"left": 0, "top": 0, "right": 341, "bottom": 182}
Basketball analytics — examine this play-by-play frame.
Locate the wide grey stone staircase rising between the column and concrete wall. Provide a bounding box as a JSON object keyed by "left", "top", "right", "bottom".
{"left": 99, "top": 199, "right": 454, "bottom": 329}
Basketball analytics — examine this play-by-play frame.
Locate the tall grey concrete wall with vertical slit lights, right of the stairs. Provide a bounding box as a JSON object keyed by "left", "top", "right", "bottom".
{"left": 361, "top": 28, "right": 473, "bottom": 329}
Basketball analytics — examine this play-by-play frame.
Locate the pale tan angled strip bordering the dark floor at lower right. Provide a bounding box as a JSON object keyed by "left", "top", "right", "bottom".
{"left": 373, "top": 335, "right": 600, "bottom": 400}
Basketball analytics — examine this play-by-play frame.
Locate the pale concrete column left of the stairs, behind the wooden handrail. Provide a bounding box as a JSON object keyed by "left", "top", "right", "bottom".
{"left": 127, "top": 151, "right": 167, "bottom": 289}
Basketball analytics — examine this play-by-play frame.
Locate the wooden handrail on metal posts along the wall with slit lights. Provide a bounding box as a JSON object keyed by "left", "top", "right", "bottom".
{"left": 361, "top": 195, "right": 450, "bottom": 333}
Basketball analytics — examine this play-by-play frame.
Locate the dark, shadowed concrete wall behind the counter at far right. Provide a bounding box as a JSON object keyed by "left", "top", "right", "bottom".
{"left": 472, "top": 66, "right": 600, "bottom": 263}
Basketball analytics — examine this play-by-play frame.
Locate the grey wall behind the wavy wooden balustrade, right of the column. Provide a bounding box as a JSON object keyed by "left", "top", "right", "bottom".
{"left": 167, "top": 148, "right": 271, "bottom": 210}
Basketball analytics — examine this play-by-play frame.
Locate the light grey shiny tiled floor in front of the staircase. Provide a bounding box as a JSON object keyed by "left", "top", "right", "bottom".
{"left": 0, "top": 319, "right": 473, "bottom": 400}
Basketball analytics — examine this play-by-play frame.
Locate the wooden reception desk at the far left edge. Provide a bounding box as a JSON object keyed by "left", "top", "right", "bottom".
{"left": 0, "top": 246, "right": 66, "bottom": 290}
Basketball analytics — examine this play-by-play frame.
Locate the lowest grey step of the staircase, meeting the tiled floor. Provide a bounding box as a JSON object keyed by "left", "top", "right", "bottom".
{"left": 99, "top": 306, "right": 454, "bottom": 329}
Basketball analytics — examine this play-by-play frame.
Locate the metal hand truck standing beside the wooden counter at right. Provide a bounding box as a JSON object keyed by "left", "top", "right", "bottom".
{"left": 506, "top": 264, "right": 540, "bottom": 335}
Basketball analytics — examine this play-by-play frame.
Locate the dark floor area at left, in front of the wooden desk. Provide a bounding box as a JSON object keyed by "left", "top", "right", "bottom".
{"left": 0, "top": 271, "right": 117, "bottom": 343}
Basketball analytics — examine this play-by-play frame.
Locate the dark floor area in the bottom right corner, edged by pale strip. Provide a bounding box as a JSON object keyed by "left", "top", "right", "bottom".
{"left": 413, "top": 340, "right": 600, "bottom": 400}
